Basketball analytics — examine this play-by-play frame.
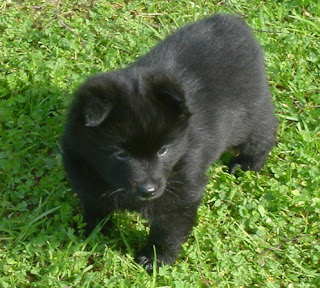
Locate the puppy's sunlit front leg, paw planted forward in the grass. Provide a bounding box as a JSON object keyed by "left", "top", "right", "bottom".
{"left": 135, "top": 204, "right": 198, "bottom": 272}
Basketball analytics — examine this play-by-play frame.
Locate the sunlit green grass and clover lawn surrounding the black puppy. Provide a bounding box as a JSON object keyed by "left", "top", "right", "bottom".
{"left": 0, "top": 0, "right": 320, "bottom": 288}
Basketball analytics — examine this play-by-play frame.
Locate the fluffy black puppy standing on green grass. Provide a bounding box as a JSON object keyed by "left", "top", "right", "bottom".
{"left": 63, "top": 15, "right": 277, "bottom": 270}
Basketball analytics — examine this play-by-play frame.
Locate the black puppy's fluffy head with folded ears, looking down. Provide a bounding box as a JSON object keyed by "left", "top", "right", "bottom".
{"left": 71, "top": 70, "right": 190, "bottom": 201}
